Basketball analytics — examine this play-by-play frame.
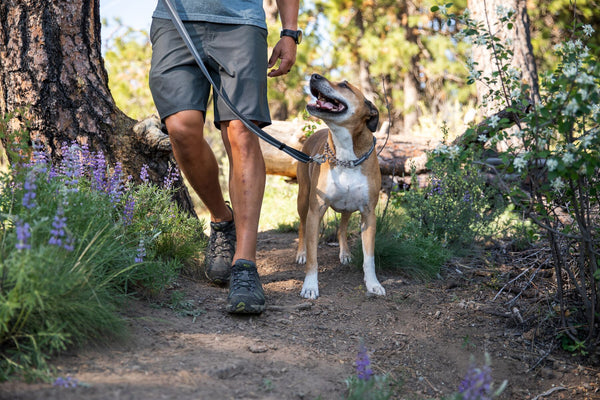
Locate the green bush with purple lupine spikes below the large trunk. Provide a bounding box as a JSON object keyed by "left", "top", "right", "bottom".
{"left": 0, "top": 140, "right": 202, "bottom": 380}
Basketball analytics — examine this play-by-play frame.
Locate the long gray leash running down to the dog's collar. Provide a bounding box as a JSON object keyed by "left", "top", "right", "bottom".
{"left": 163, "top": 0, "right": 316, "bottom": 163}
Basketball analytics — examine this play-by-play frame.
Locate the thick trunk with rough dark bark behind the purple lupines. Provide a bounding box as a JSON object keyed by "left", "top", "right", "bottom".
{"left": 0, "top": 0, "right": 195, "bottom": 215}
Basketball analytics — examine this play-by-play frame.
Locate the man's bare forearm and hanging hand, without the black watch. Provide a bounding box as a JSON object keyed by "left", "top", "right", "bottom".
{"left": 268, "top": 0, "right": 300, "bottom": 78}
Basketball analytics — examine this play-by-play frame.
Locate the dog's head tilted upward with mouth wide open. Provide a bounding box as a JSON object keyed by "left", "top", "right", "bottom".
{"left": 306, "top": 74, "right": 379, "bottom": 132}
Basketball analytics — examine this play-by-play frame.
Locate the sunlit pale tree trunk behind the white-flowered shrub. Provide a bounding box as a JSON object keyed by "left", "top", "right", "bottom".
{"left": 468, "top": 0, "right": 540, "bottom": 116}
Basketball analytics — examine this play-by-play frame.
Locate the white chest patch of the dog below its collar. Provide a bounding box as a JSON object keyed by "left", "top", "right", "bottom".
{"left": 325, "top": 167, "right": 369, "bottom": 212}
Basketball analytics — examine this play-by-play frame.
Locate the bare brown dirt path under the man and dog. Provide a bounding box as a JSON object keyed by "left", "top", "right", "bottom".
{"left": 0, "top": 232, "right": 600, "bottom": 400}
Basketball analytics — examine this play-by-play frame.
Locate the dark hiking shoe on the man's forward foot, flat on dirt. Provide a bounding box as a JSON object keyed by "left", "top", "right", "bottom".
{"left": 227, "top": 260, "right": 265, "bottom": 314}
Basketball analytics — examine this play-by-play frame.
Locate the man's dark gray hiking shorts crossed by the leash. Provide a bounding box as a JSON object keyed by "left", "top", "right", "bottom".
{"left": 150, "top": 18, "right": 271, "bottom": 127}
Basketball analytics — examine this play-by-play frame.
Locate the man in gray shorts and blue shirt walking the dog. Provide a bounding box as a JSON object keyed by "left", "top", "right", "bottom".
{"left": 150, "top": 0, "right": 301, "bottom": 313}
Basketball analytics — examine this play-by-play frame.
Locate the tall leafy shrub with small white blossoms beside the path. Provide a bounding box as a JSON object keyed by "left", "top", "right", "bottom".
{"left": 436, "top": 6, "right": 600, "bottom": 350}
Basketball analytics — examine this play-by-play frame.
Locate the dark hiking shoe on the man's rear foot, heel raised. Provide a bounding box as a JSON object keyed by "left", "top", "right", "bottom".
{"left": 204, "top": 214, "right": 235, "bottom": 285}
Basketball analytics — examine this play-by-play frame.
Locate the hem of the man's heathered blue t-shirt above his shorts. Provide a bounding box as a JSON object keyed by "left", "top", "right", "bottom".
{"left": 152, "top": 0, "right": 267, "bottom": 29}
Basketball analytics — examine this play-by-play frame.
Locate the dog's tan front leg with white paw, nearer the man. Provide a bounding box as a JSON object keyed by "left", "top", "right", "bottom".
{"left": 300, "top": 206, "right": 327, "bottom": 299}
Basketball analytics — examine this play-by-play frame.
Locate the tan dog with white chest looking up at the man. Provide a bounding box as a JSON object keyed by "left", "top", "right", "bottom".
{"left": 296, "top": 74, "right": 385, "bottom": 299}
